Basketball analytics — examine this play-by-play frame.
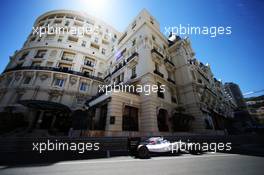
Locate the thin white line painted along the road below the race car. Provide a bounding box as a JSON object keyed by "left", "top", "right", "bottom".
{"left": 55, "top": 153, "right": 236, "bottom": 165}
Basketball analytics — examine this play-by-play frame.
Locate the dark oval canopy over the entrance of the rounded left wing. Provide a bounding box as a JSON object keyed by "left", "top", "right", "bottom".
{"left": 18, "top": 100, "right": 71, "bottom": 112}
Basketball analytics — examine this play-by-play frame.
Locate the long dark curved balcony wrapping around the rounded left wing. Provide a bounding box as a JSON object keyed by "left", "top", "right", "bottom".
{"left": 3, "top": 66, "right": 103, "bottom": 82}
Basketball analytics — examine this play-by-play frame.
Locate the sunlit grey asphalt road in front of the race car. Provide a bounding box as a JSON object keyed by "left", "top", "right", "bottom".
{"left": 0, "top": 153, "right": 264, "bottom": 175}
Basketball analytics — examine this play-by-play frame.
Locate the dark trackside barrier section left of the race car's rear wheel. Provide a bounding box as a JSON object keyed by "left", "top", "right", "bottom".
{"left": 0, "top": 137, "right": 127, "bottom": 165}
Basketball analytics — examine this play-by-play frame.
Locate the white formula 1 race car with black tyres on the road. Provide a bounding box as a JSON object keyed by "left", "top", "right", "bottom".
{"left": 128, "top": 137, "right": 201, "bottom": 159}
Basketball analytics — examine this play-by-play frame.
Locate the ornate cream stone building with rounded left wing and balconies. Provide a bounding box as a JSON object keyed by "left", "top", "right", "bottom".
{"left": 0, "top": 10, "right": 233, "bottom": 136}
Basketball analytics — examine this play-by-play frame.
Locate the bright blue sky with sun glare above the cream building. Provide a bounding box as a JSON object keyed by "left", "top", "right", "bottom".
{"left": 0, "top": 0, "right": 264, "bottom": 95}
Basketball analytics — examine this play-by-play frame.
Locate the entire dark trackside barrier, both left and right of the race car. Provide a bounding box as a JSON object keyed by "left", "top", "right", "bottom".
{"left": 0, "top": 134, "right": 264, "bottom": 165}
